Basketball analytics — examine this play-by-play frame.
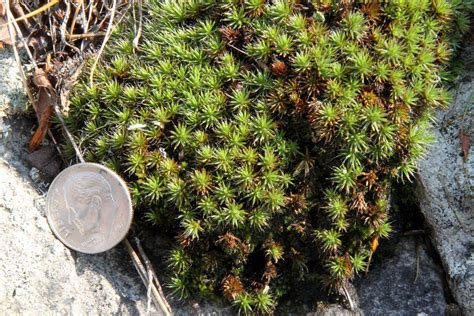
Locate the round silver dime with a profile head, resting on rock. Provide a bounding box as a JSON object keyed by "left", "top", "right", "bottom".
{"left": 46, "top": 163, "right": 133, "bottom": 254}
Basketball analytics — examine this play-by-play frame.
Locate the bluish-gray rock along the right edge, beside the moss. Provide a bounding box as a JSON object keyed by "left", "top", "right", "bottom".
{"left": 417, "top": 45, "right": 474, "bottom": 315}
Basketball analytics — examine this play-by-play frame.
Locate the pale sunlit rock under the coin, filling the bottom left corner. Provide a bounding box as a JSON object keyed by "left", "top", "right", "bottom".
{"left": 0, "top": 162, "right": 156, "bottom": 315}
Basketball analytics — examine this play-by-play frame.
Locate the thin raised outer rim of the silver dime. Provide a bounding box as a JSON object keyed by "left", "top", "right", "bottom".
{"left": 46, "top": 162, "right": 134, "bottom": 254}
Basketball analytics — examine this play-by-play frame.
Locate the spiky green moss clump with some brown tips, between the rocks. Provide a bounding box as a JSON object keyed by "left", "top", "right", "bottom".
{"left": 68, "top": 0, "right": 467, "bottom": 313}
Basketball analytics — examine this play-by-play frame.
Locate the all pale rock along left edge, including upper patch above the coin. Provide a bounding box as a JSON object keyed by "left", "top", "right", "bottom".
{"left": 0, "top": 49, "right": 154, "bottom": 315}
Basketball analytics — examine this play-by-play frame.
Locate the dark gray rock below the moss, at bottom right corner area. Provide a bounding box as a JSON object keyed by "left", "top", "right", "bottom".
{"left": 357, "top": 237, "right": 447, "bottom": 316}
